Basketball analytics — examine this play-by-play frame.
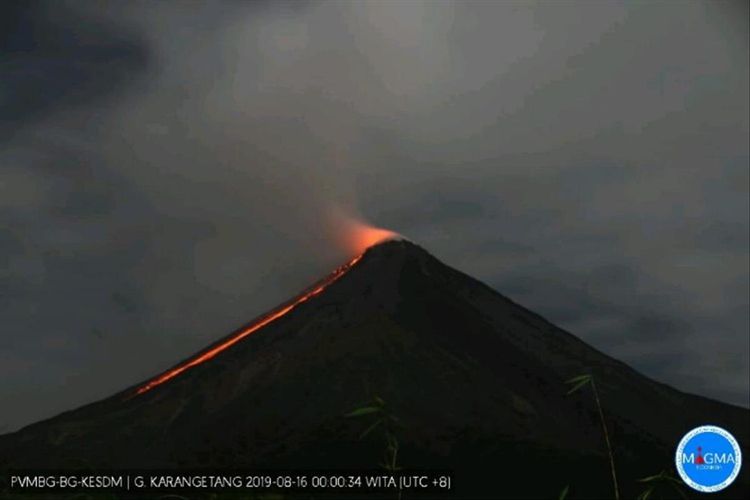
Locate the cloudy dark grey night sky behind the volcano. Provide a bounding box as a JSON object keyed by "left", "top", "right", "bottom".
{"left": 0, "top": 1, "right": 750, "bottom": 430}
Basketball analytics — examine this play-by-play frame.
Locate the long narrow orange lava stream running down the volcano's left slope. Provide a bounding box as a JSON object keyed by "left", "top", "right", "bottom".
{"left": 133, "top": 252, "right": 368, "bottom": 396}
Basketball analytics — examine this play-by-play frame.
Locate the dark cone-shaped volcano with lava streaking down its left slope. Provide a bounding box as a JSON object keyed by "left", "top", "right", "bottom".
{"left": 0, "top": 240, "right": 750, "bottom": 498}
